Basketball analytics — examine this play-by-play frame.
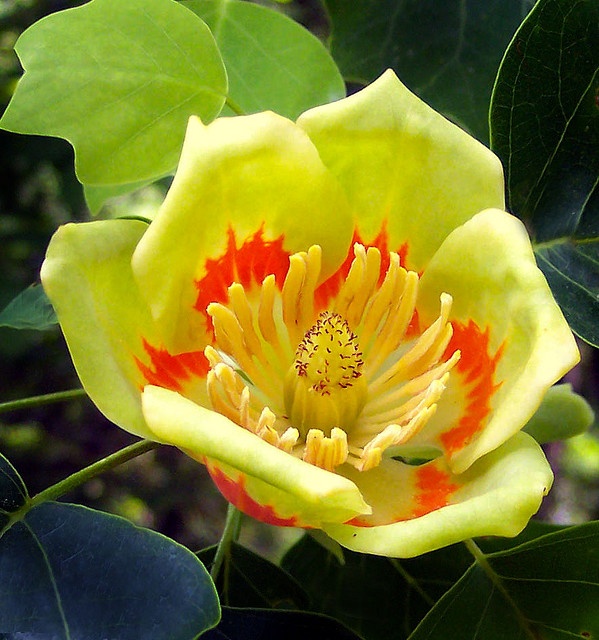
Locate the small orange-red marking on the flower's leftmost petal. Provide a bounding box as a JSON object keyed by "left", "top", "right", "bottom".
{"left": 135, "top": 338, "right": 210, "bottom": 391}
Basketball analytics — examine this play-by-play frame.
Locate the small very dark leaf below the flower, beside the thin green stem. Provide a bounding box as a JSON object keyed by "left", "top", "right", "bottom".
{"left": 199, "top": 544, "right": 308, "bottom": 609}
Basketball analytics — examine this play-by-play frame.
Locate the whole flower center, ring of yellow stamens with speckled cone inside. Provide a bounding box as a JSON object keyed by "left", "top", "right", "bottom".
{"left": 205, "top": 244, "right": 460, "bottom": 471}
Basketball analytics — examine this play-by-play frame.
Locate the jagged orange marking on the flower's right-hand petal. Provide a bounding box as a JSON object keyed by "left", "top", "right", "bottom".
{"left": 440, "top": 320, "right": 504, "bottom": 455}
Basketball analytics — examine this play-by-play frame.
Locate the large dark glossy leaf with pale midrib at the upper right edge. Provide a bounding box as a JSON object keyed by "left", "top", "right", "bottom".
{"left": 491, "top": 0, "right": 599, "bottom": 346}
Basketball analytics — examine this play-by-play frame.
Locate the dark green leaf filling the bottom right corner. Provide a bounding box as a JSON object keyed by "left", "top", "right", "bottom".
{"left": 410, "top": 522, "right": 599, "bottom": 640}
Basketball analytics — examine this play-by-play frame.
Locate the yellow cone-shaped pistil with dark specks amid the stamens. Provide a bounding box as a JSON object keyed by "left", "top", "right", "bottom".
{"left": 284, "top": 311, "right": 367, "bottom": 438}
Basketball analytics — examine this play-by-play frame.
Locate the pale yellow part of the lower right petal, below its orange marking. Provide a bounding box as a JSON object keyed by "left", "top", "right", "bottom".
{"left": 323, "top": 433, "right": 553, "bottom": 558}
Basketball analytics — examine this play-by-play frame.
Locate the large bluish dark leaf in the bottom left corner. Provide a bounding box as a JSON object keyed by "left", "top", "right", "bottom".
{"left": 0, "top": 502, "right": 219, "bottom": 640}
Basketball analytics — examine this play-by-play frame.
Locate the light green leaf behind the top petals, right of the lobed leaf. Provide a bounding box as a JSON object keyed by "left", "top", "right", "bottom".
{"left": 181, "top": 0, "right": 345, "bottom": 119}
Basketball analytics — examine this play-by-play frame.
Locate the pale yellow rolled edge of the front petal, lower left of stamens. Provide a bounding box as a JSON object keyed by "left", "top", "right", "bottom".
{"left": 143, "top": 386, "right": 370, "bottom": 526}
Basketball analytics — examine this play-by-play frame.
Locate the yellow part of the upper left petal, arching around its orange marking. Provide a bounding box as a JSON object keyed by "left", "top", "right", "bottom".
{"left": 133, "top": 112, "right": 353, "bottom": 351}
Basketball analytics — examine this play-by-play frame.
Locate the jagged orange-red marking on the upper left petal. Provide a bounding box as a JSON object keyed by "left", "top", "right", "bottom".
{"left": 194, "top": 224, "right": 290, "bottom": 314}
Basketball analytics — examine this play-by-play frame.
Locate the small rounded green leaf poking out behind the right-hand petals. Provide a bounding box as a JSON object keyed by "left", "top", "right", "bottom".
{"left": 524, "top": 384, "right": 595, "bottom": 444}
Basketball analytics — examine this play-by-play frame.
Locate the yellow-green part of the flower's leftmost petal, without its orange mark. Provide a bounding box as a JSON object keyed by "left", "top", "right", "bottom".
{"left": 41, "top": 220, "right": 154, "bottom": 437}
